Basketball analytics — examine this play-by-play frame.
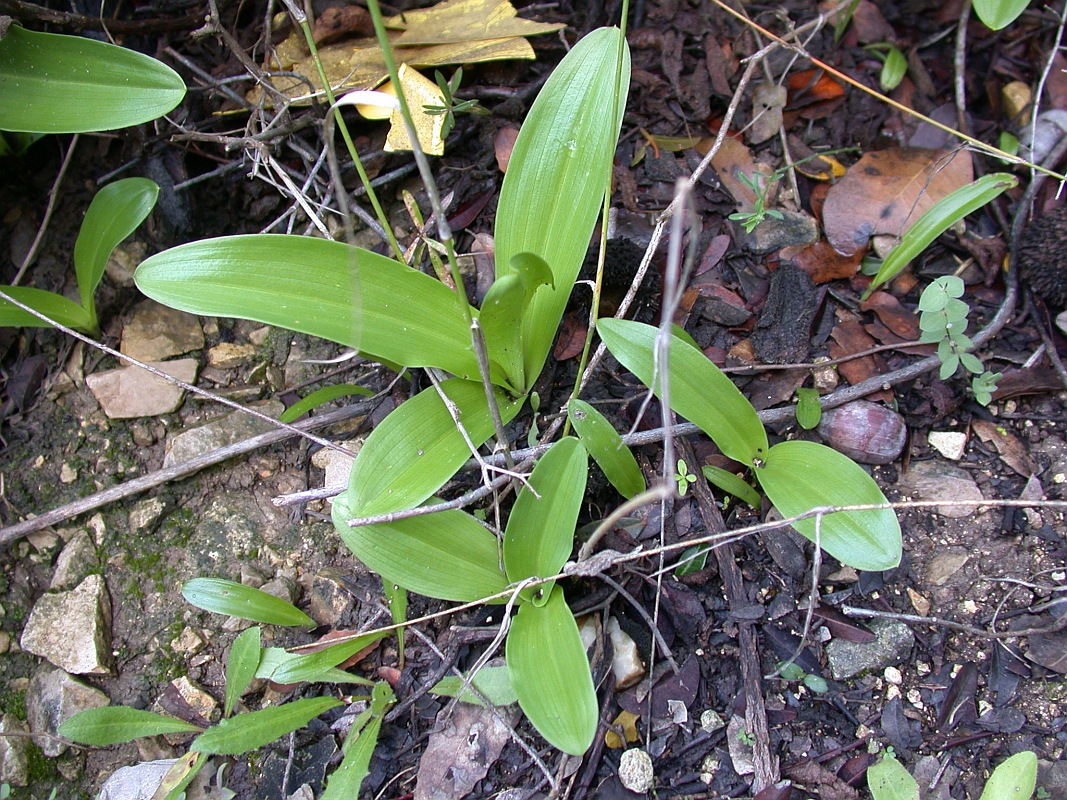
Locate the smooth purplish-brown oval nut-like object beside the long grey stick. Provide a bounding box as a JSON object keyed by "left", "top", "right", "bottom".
{"left": 818, "top": 400, "right": 908, "bottom": 464}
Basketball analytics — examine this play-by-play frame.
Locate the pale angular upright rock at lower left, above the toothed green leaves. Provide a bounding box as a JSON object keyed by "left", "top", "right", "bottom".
{"left": 21, "top": 575, "right": 111, "bottom": 675}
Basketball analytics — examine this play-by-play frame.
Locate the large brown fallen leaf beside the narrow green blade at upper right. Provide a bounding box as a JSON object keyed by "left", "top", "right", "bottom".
{"left": 823, "top": 147, "right": 974, "bottom": 255}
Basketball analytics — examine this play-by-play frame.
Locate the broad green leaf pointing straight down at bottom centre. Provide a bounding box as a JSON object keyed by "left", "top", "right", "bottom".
{"left": 506, "top": 586, "right": 599, "bottom": 755}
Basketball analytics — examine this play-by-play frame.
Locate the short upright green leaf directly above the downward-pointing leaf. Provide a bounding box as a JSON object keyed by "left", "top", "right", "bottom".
{"left": 504, "top": 436, "right": 589, "bottom": 598}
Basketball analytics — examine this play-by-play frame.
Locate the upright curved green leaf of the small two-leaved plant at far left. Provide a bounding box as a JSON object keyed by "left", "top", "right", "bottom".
{"left": 74, "top": 180, "right": 159, "bottom": 322}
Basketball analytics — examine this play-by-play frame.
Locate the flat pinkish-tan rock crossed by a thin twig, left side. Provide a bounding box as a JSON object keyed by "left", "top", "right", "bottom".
{"left": 85, "top": 358, "right": 197, "bottom": 419}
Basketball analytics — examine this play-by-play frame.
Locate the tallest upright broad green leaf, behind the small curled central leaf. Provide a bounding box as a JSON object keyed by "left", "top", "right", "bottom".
{"left": 495, "top": 28, "right": 630, "bottom": 381}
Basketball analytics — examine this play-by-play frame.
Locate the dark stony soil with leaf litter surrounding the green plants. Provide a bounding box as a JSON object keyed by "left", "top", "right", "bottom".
{"left": 0, "top": 0, "right": 1067, "bottom": 800}
